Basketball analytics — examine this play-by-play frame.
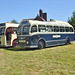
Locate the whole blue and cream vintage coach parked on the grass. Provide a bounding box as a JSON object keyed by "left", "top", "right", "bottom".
{"left": 18, "top": 20, "right": 74, "bottom": 48}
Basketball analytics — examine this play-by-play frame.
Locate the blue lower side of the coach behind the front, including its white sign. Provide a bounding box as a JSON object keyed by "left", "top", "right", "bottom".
{"left": 30, "top": 34, "right": 74, "bottom": 46}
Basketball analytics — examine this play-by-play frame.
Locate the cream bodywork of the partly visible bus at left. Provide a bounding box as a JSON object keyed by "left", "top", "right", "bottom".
{"left": 0, "top": 22, "right": 19, "bottom": 46}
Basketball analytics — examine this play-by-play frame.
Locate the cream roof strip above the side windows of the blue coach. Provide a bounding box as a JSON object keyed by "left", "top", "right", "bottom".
{"left": 29, "top": 20, "right": 73, "bottom": 28}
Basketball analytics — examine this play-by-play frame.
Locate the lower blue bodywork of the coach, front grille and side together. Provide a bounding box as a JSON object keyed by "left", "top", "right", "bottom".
{"left": 18, "top": 33, "right": 74, "bottom": 48}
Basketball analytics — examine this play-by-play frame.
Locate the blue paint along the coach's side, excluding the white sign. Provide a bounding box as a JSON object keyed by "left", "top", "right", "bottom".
{"left": 31, "top": 34, "right": 74, "bottom": 45}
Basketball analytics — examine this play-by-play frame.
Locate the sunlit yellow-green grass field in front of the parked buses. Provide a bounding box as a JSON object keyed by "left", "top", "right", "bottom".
{"left": 0, "top": 42, "right": 75, "bottom": 75}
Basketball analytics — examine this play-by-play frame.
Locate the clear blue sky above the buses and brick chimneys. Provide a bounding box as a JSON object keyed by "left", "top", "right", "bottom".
{"left": 0, "top": 0, "right": 75, "bottom": 23}
